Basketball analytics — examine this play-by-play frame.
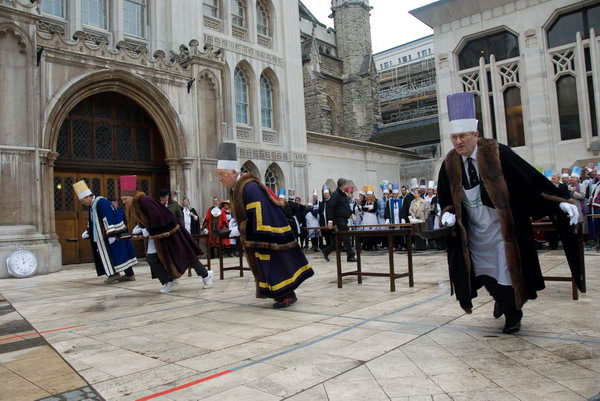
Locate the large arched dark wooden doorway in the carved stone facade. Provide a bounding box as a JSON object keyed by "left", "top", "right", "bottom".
{"left": 53, "top": 92, "right": 169, "bottom": 264}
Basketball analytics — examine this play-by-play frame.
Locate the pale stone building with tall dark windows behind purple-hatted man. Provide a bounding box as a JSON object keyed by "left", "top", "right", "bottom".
{"left": 411, "top": 0, "right": 600, "bottom": 170}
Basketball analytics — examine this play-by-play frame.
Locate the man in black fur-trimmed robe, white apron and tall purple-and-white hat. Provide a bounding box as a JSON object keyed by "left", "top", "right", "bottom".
{"left": 438, "top": 93, "right": 581, "bottom": 334}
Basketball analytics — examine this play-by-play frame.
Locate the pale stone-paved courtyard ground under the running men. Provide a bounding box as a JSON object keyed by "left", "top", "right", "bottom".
{"left": 0, "top": 251, "right": 600, "bottom": 401}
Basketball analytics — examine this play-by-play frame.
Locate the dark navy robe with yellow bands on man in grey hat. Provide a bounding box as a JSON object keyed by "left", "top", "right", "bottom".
{"left": 232, "top": 174, "right": 314, "bottom": 298}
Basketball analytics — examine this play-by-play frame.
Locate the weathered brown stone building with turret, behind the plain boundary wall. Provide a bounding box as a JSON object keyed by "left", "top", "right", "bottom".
{"left": 300, "top": 0, "right": 381, "bottom": 141}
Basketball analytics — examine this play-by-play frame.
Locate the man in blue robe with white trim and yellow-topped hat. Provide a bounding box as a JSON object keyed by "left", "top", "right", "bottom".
{"left": 73, "top": 180, "right": 137, "bottom": 284}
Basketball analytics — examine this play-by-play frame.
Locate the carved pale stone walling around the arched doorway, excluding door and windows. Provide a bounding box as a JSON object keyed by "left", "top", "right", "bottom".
{"left": 0, "top": 0, "right": 308, "bottom": 277}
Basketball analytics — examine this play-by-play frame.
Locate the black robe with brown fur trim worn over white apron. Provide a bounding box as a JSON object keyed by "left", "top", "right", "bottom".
{"left": 438, "top": 138, "right": 581, "bottom": 310}
